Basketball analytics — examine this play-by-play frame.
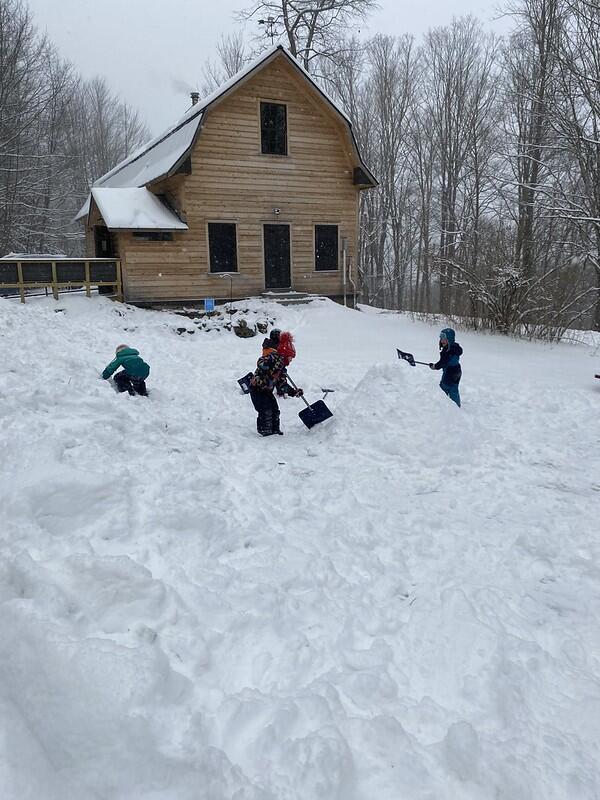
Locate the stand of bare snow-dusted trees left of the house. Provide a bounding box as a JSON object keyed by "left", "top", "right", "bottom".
{"left": 0, "top": 0, "right": 148, "bottom": 255}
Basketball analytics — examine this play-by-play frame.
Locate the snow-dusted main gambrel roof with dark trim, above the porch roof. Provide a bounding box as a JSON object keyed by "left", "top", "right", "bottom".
{"left": 83, "top": 45, "right": 377, "bottom": 200}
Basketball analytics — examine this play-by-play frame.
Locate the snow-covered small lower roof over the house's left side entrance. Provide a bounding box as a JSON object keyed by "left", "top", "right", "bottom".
{"left": 92, "top": 187, "right": 188, "bottom": 231}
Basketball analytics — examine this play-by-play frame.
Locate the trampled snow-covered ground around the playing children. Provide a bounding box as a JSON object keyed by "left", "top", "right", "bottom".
{"left": 0, "top": 297, "right": 600, "bottom": 800}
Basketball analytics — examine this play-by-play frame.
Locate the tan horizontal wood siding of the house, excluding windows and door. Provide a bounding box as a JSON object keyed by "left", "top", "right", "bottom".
{"left": 96, "top": 52, "right": 359, "bottom": 302}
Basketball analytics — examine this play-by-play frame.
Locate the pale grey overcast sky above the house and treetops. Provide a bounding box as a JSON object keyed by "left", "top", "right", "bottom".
{"left": 27, "top": 0, "right": 506, "bottom": 134}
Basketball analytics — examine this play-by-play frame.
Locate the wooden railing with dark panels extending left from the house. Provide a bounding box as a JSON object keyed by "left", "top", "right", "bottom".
{"left": 0, "top": 258, "right": 123, "bottom": 303}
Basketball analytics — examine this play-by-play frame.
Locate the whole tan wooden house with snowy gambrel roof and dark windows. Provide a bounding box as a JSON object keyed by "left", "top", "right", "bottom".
{"left": 78, "top": 46, "right": 376, "bottom": 304}
